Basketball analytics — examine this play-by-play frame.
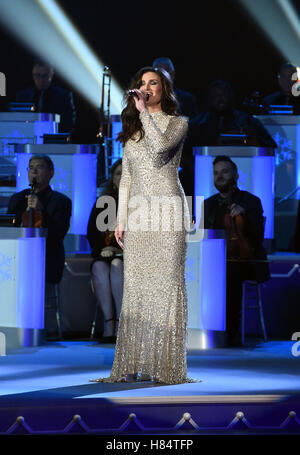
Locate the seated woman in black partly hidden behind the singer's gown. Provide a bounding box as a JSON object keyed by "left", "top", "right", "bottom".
{"left": 87, "top": 159, "right": 123, "bottom": 343}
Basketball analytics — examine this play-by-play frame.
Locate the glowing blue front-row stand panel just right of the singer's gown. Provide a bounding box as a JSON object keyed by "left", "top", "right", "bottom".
{"left": 199, "top": 239, "right": 226, "bottom": 330}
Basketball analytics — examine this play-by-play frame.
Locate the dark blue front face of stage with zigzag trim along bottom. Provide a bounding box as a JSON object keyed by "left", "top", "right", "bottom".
{"left": 0, "top": 396, "right": 300, "bottom": 434}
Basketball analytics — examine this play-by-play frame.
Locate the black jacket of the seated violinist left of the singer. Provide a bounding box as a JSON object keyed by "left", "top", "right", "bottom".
{"left": 7, "top": 186, "right": 72, "bottom": 283}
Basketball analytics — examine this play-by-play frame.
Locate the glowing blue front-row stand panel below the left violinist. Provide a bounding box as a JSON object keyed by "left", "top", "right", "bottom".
{"left": 16, "top": 238, "right": 45, "bottom": 329}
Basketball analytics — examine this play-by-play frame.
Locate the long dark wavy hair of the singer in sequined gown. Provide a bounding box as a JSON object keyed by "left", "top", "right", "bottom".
{"left": 117, "top": 66, "right": 178, "bottom": 146}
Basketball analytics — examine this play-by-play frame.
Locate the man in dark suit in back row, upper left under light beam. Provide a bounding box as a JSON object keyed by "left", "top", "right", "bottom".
{"left": 16, "top": 61, "right": 76, "bottom": 133}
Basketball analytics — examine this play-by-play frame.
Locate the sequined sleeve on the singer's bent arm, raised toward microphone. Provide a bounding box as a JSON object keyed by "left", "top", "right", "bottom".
{"left": 140, "top": 109, "right": 188, "bottom": 167}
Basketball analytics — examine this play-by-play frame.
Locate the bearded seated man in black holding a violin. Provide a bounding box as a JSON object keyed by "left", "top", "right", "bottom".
{"left": 204, "top": 156, "right": 270, "bottom": 346}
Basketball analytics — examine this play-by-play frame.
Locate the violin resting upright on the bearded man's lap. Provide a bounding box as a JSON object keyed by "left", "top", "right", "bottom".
{"left": 224, "top": 191, "right": 254, "bottom": 259}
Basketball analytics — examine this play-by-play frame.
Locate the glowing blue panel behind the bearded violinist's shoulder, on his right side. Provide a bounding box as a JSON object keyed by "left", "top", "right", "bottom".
{"left": 252, "top": 156, "right": 275, "bottom": 239}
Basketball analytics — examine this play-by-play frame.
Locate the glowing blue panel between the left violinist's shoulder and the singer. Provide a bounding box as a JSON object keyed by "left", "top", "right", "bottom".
{"left": 72, "top": 153, "right": 97, "bottom": 234}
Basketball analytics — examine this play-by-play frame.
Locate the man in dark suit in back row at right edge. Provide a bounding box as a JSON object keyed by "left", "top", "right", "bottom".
{"left": 263, "top": 63, "right": 300, "bottom": 115}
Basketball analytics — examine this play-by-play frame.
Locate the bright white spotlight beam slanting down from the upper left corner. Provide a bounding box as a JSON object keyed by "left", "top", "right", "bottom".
{"left": 0, "top": 0, "right": 123, "bottom": 114}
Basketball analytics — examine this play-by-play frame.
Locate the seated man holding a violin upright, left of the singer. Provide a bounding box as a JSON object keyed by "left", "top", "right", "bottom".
{"left": 7, "top": 155, "right": 72, "bottom": 337}
